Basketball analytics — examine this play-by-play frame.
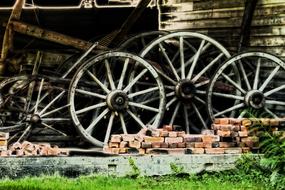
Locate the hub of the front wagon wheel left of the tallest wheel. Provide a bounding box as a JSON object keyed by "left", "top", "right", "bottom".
{"left": 107, "top": 90, "right": 129, "bottom": 111}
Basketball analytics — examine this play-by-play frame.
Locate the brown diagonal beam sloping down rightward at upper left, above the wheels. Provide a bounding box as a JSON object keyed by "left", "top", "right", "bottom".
{"left": 10, "top": 21, "right": 107, "bottom": 51}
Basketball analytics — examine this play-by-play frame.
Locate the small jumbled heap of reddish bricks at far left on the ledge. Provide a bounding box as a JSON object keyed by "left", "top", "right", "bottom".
{"left": 0, "top": 141, "right": 69, "bottom": 157}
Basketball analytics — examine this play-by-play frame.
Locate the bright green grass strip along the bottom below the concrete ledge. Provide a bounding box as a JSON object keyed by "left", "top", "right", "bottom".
{"left": 0, "top": 172, "right": 269, "bottom": 190}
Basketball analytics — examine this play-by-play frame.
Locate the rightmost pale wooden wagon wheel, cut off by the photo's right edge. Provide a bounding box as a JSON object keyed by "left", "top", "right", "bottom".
{"left": 207, "top": 52, "right": 285, "bottom": 119}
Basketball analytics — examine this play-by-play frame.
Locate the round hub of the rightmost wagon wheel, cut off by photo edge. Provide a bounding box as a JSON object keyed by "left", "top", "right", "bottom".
{"left": 245, "top": 90, "right": 265, "bottom": 109}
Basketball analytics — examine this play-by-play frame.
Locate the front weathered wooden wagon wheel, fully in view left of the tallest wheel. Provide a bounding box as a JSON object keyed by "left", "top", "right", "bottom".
{"left": 69, "top": 52, "right": 165, "bottom": 146}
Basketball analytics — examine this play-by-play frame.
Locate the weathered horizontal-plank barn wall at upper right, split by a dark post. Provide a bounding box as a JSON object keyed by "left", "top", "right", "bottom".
{"left": 159, "top": 0, "right": 285, "bottom": 58}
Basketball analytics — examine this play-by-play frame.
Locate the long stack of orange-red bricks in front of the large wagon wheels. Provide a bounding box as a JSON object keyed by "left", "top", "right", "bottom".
{"left": 104, "top": 118, "right": 285, "bottom": 155}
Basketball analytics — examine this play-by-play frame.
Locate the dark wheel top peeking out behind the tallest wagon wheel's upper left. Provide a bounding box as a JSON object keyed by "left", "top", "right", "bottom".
{"left": 119, "top": 31, "right": 168, "bottom": 54}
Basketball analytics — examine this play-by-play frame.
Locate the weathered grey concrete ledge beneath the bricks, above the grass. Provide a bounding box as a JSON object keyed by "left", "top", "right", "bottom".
{"left": 0, "top": 154, "right": 244, "bottom": 178}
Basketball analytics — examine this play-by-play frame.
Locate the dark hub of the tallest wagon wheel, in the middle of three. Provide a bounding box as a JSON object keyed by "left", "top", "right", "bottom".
{"left": 175, "top": 79, "right": 196, "bottom": 100}
